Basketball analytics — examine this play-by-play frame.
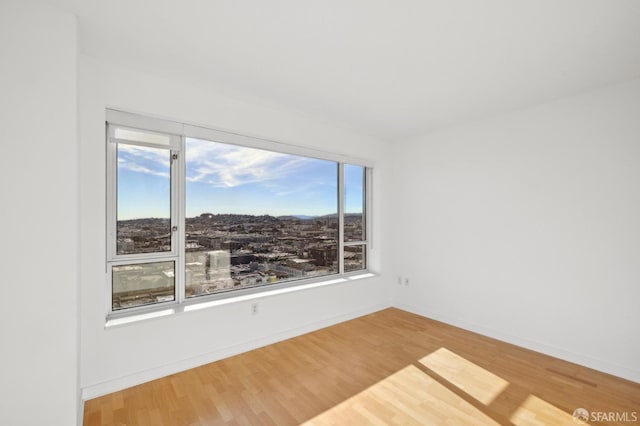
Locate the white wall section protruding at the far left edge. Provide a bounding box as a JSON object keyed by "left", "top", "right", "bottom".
{"left": 0, "top": 1, "right": 79, "bottom": 426}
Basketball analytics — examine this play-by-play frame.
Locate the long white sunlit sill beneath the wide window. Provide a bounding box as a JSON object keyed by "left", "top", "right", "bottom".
{"left": 105, "top": 271, "right": 378, "bottom": 329}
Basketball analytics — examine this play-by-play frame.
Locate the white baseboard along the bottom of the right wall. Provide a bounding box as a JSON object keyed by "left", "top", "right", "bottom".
{"left": 393, "top": 304, "right": 640, "bottom": 383}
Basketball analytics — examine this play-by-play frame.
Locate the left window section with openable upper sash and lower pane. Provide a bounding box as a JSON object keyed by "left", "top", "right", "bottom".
{"left": 107, "top": 121, "right": 180, "bottom": 312}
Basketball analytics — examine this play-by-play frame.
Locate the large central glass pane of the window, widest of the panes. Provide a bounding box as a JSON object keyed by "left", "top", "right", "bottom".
{"left": 185, "top": 138, "right": 338, "bottom": 297}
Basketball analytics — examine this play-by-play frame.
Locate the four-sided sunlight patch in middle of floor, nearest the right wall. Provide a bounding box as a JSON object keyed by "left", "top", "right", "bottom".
{"left": 420, "top": 348, "right": 509, "bottom": 405}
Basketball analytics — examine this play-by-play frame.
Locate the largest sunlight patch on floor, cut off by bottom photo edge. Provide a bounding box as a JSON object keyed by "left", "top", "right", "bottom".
{"left": 304, "top": 365, "right": 498, "bottom": 425}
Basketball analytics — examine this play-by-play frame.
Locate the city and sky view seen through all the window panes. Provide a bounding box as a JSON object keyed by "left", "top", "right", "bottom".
{"left": 112, "top": 135, "right": 366, "bottom": 311}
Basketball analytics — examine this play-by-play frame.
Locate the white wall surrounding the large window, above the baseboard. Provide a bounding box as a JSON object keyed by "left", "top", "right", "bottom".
{"left": 78, "top": 57, "right": 390, "bottom": 398}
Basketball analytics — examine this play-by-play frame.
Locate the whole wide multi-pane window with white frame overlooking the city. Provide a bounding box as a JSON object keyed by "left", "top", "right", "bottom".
{"left": 107, "top": 110, "right": 370, "bottom": 314}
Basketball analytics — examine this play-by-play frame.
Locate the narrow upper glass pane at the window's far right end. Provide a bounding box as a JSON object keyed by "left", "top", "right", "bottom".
{"left": 344, "top": 164, "right": 367, "bottom": 241}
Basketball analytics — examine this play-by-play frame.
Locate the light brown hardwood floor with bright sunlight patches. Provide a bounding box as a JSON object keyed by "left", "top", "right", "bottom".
{"left": 84, "top": 308, "right": 640, "bottom": 426}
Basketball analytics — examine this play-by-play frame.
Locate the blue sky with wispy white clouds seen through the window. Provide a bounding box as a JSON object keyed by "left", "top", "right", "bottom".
{"left": 118, "top": 138, "right": 363, "bottom": 220}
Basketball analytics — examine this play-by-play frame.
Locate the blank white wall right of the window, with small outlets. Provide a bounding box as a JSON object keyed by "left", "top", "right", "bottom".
{"left": 392, "top": 80, "right": 640, "bottom": 381}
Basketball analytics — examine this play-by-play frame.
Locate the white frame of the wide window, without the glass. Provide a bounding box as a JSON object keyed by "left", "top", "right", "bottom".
{"left": 105, "top": 109, "right": 373, "bottom": 321}
